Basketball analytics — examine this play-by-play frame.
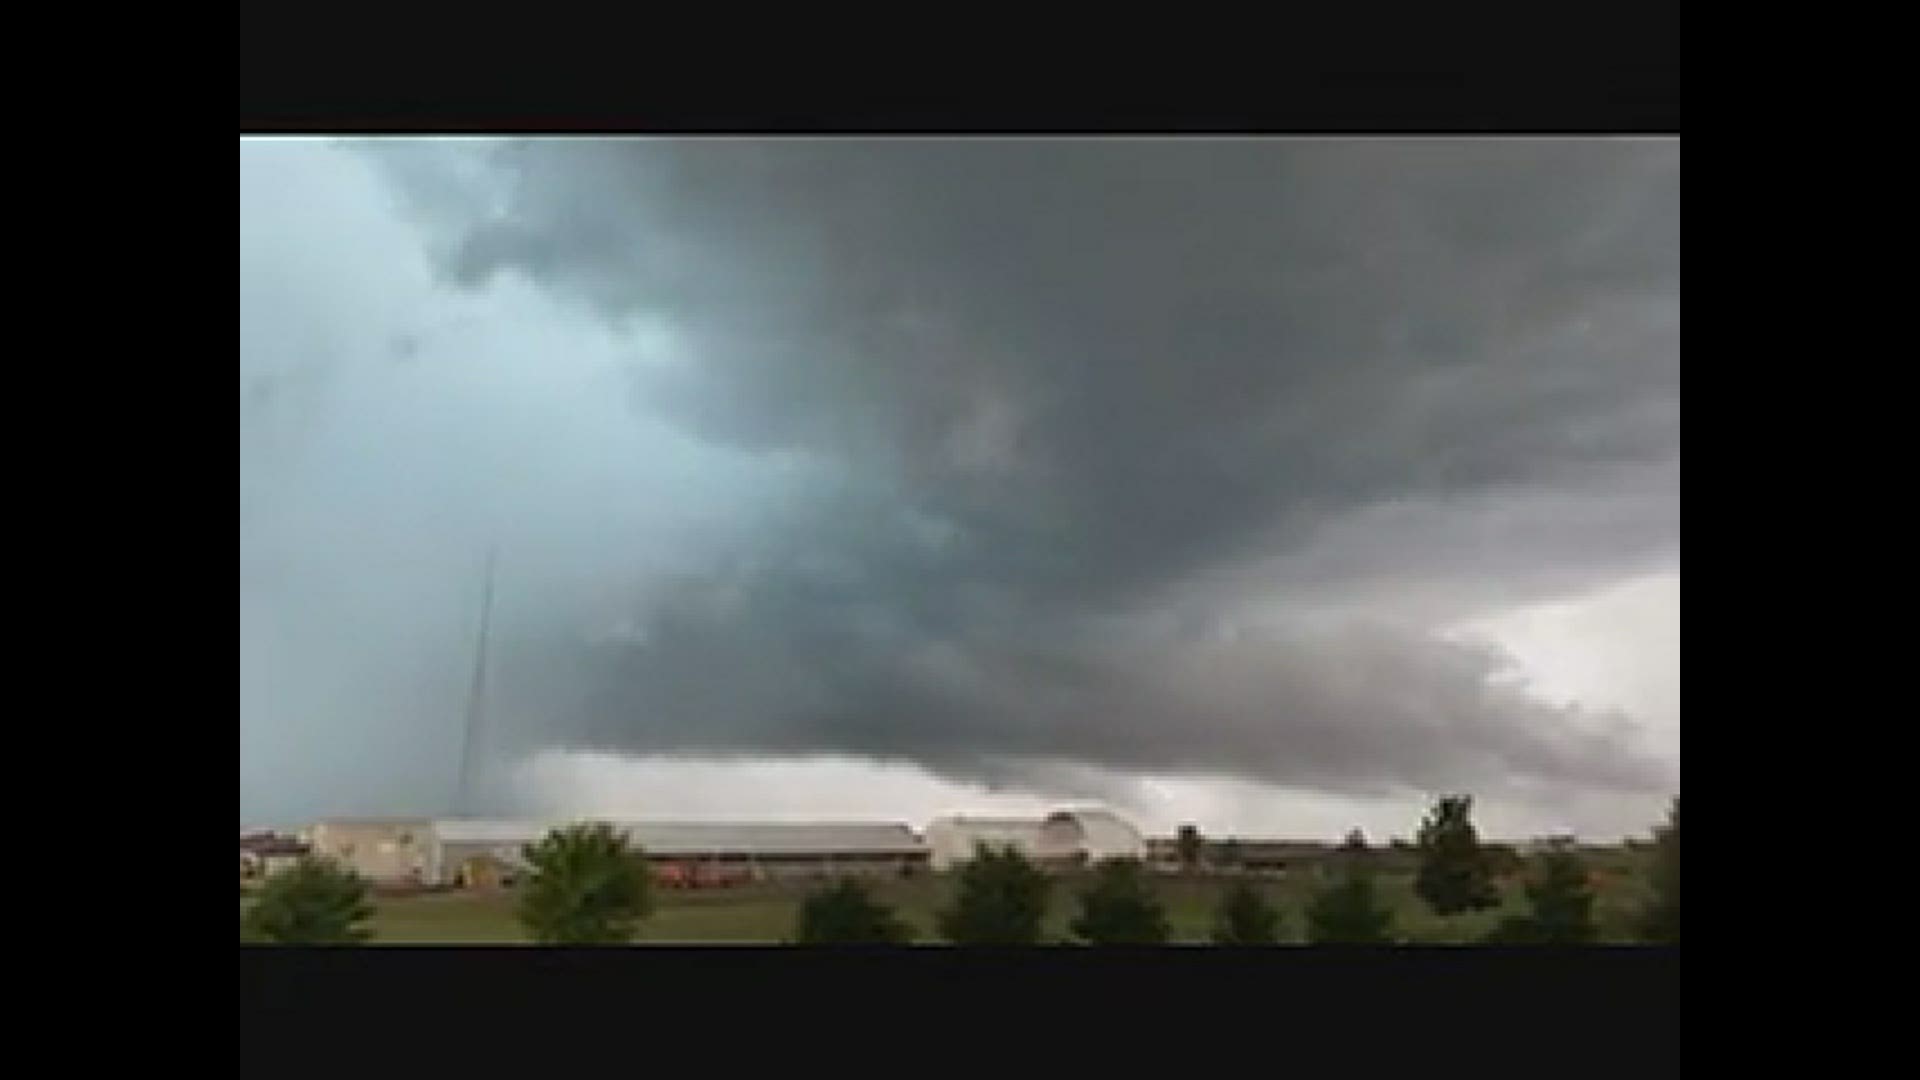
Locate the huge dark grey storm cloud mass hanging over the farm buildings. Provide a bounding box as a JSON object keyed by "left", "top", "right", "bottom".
{"left": 353, "top": 140, "right": 1678, "bottom": 790}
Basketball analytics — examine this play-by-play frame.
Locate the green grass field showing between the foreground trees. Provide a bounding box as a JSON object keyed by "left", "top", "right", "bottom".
{"left": 240, "top": 851, "right": 1645, "bottom": 944}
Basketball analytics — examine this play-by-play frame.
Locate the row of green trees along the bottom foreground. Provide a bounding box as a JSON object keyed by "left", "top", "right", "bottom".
{"left": 242, "top": 796, "right": 1680, "bottom": 945}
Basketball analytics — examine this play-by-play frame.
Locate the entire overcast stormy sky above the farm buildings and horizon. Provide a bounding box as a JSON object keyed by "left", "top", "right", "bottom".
{"left": 240, "top": 138, "right": 1680, "bottom": 838}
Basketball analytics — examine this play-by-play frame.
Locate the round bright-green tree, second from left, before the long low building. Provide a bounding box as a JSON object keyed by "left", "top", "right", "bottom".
{"left": 518, "top": 822, "right": 653, "bottom": 945}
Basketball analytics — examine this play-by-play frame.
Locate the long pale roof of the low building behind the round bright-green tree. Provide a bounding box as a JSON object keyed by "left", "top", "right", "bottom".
{"left": 434, "top": 819, "right": 925, "bottom": 855}
